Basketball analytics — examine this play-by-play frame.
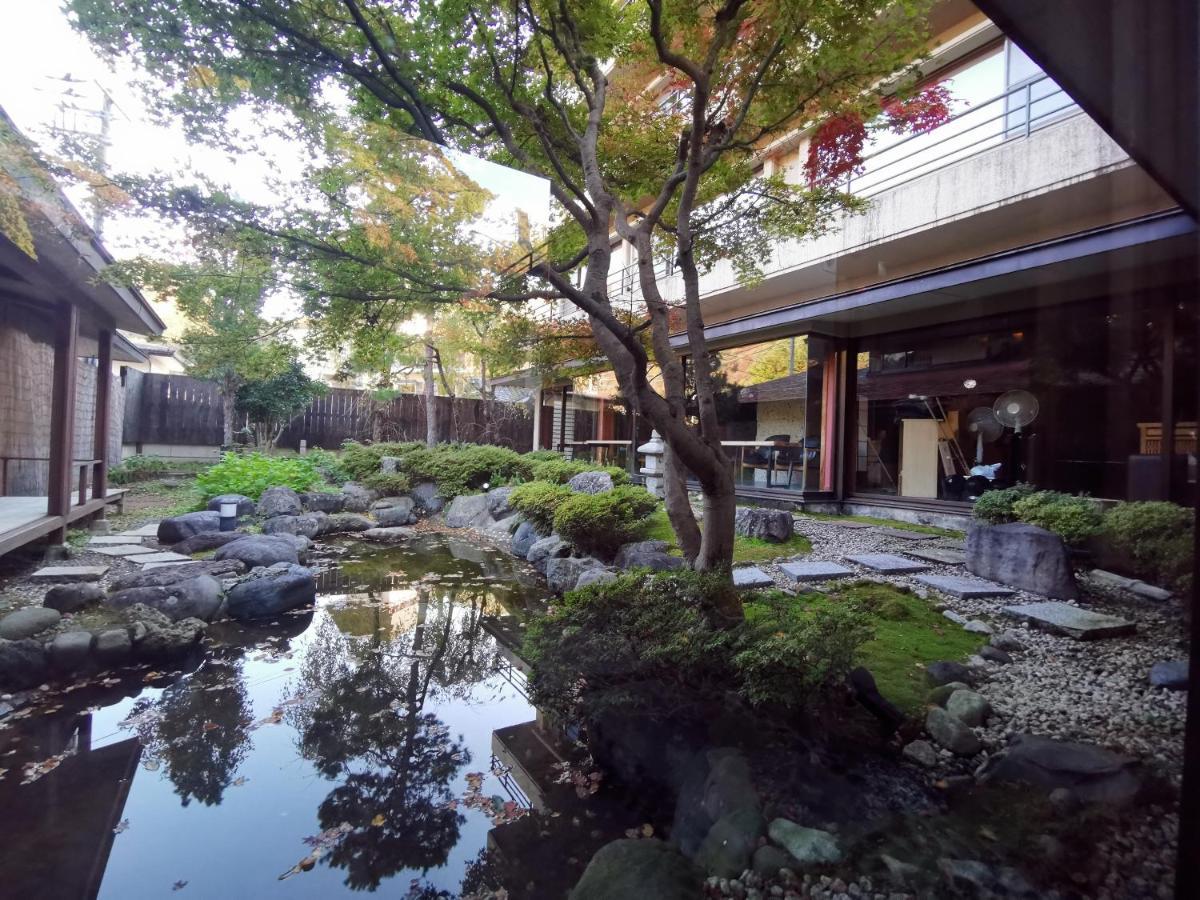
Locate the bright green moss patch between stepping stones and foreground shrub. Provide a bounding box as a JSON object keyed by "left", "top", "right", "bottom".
{"left": 746, "top": 581, "right": 983, "bottom": 714}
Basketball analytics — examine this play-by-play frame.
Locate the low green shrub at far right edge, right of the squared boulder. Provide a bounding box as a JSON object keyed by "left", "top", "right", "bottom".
{"left": 1100, "top": 500, "right": 1195, "bottom": 590}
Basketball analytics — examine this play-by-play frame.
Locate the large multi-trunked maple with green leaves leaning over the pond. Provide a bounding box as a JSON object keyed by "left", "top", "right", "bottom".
{"left": 75, "top": 0, "right": 928, "bottom": 617}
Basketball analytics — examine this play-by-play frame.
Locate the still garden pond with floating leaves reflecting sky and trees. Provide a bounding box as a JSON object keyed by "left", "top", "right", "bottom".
{"left": 0, "top": 535, "right": 643, "bottom": 900}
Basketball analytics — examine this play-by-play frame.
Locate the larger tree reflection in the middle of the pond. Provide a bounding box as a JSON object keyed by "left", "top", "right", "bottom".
{"left": 287, "top": 586, "right": 499, "bottom": 895}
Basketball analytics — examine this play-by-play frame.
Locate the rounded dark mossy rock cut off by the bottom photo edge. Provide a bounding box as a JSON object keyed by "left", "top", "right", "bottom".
{"left": 569, "top": 838, "right": 701, "bottom": 900}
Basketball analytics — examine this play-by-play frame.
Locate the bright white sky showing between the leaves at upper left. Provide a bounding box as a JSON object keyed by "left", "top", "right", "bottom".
{"left": 0, "top": 0, "right": 550, "bottom": 328}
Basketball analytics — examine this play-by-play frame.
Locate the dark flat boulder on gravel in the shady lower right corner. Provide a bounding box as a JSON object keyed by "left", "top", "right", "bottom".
{"left": 983, "top": 734, "right": 1140, "bottom": 804}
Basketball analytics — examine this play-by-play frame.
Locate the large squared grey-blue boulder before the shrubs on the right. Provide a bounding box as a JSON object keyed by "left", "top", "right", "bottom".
{"left": 967, "top": 522, "right": 1079, "bottom": 600}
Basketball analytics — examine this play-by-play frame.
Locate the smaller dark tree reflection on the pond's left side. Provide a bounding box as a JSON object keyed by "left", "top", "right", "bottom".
{"left": 128, "top": 652, "right": 252, "bottom": 806}
